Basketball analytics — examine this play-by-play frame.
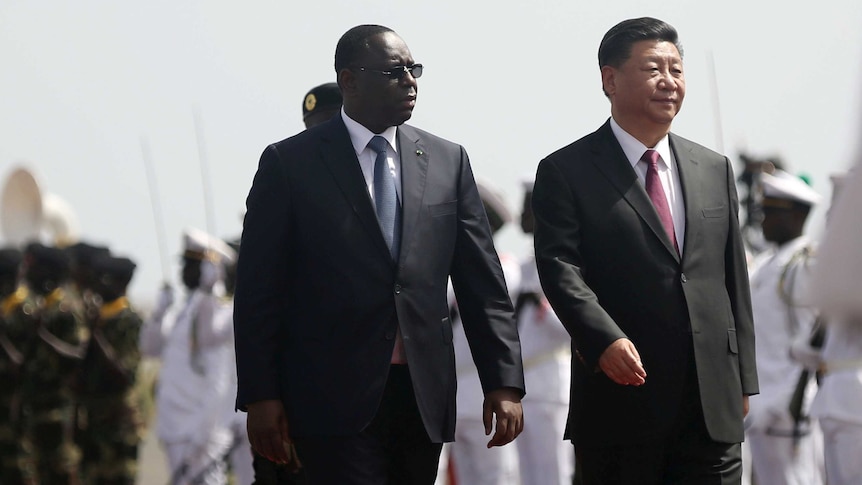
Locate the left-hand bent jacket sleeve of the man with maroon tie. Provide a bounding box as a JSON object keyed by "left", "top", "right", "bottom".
{"left": 532, "top": 159, "right": 626, "bottom": 369}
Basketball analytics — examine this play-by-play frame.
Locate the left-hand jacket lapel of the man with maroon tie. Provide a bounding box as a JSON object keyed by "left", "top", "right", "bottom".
{"left": 593, "top": 120, "right": 679, "bottom": 262}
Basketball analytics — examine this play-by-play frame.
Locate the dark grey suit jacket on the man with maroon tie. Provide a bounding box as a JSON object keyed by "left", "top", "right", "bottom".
{"left": 533, "top": 122, "right": 758, "bottom": 444}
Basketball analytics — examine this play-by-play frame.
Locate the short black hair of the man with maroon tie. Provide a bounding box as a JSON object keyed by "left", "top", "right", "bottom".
{"left": 599, "top": 17, "right": 682, "bottom": 68}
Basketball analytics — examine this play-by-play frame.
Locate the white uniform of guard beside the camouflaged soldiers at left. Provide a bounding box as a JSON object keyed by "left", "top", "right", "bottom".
{"left": 141, "top": 290, "right": 235, "bottom": 485}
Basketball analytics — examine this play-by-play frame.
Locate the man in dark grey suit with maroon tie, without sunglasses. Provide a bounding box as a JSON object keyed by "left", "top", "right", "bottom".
{"left": 532, "top": 18, "right": 758, "bottom": 484}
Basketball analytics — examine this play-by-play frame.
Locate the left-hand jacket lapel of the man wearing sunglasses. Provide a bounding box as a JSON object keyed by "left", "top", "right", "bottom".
{"left": 320, "top": 116, "right": 392, "bottom": 260}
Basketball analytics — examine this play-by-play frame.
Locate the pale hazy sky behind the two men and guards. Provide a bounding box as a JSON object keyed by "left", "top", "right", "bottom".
{"left": 0, "top": 0, "right": 862, "bottom": 302}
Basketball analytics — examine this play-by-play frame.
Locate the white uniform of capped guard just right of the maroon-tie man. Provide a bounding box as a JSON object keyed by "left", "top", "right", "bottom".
{"left": 746, "top": 237, "right": 824, "bottom": 485}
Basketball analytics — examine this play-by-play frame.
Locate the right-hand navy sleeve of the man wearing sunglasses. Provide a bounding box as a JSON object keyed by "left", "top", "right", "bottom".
{"left": 450, "top": 148, "right": 525, "bottom": 395}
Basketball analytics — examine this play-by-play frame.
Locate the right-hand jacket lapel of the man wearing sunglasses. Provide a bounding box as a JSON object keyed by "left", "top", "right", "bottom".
{"left": 398, "top": 125, "right": 428, "bottom": 261}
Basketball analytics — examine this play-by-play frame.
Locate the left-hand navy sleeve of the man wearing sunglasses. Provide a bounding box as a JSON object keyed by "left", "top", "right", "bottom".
{"left": 234, "top": 145, "right": 290, "bottom": 410}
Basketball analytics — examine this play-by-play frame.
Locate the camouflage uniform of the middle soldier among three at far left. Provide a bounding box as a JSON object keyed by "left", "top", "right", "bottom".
{"left": 22, "top": 289, "right": 87, "bottom": 485}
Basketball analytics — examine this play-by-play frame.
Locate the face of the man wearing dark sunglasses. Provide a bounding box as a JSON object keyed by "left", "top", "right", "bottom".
{"left": 338, "top": 32, "right": 422, "bottom": 133}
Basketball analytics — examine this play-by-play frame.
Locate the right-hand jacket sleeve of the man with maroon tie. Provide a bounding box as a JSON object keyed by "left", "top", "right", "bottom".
{"left": 724, "top": 157, "right": 759, "bottom": 395}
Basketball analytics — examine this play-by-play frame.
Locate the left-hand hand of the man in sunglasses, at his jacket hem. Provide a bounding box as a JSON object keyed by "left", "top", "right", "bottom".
{"left": 246, "top": 399, "right": 291, "bottom": 464}
